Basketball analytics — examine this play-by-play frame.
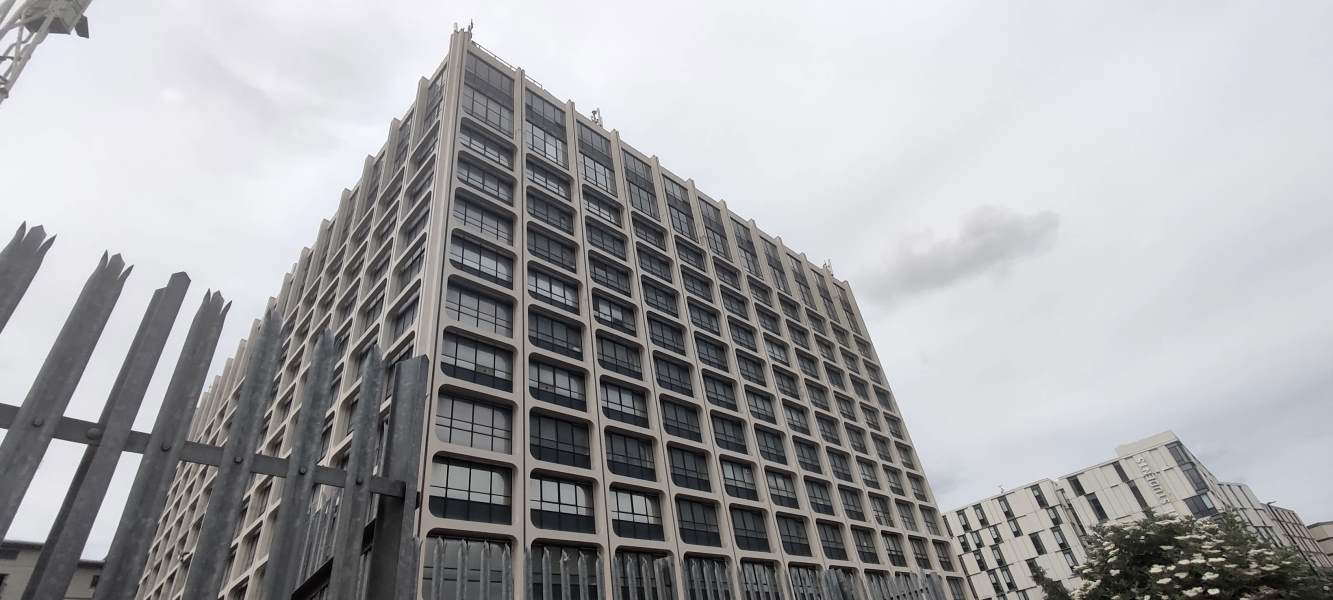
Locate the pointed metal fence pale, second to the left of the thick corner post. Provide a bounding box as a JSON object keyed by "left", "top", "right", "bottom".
{"left": 261, "top": 328, "right": 333, "bottom": 600}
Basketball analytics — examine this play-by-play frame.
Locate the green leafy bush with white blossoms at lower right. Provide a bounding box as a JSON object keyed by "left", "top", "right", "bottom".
{"left": 1071, "top": 515, "right": 1333, "bottom": 600}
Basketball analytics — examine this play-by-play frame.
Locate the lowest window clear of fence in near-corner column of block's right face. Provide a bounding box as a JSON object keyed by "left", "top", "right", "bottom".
{"left": 429, "top": 457, "right": 512, "bottom": 524}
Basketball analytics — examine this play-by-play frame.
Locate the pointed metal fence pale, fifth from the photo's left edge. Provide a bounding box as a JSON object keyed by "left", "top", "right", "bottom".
{"left": 181, "top": 305, "right": 283, "bottom": 600}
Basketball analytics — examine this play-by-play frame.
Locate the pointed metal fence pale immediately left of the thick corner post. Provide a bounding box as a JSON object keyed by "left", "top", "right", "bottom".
{"left": 329, "top": 345, "right": 384, "bottom": 600}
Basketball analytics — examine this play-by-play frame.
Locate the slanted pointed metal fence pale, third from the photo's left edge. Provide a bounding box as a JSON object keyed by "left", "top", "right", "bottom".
{"left": 23, "top": 273, "right": 189, "bottom": 600}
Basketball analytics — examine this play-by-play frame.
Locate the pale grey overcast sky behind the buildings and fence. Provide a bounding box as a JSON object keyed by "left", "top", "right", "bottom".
{"left": 0, "top": 0, "right": 1333, "bottom": 555}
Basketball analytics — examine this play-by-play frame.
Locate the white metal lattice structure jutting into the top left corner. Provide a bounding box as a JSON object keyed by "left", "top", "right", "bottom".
{"left": 0, "top": 0, "right": 92, "bottom": 103}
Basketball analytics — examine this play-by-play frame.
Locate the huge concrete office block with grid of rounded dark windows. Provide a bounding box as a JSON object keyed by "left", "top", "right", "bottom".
{"left": 132, "top": 32, "right": 966, "bottom": 600}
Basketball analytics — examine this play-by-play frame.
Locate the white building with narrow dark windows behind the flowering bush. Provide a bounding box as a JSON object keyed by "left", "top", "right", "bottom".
{"left": 945, "top": 432, "right": 1328, "bottom": 600}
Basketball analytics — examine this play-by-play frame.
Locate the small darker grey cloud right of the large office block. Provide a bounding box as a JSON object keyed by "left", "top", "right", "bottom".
{"left": 866, "top": 205, "right": 1060, "bottom": 300}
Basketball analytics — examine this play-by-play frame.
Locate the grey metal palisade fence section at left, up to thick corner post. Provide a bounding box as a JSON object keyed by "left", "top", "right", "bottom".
{"left": 0, "top": 227, "right": 428, "bottom": 600}
